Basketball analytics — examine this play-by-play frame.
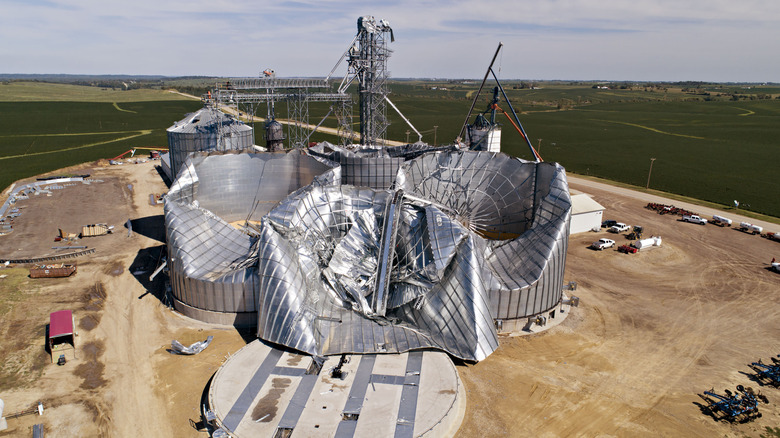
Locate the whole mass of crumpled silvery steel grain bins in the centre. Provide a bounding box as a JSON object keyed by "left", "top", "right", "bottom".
{"left": 165, "top": 145, "right": 571, "bottom": 361}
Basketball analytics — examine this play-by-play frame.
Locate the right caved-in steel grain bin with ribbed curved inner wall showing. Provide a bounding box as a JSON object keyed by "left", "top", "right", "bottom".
{"left": 399, "top": 151, "right": 571, "bottom": 319}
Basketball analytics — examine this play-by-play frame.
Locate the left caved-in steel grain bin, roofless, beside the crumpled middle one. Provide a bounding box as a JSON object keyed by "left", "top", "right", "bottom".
{"left": 165, "top": 152, "right": 331, "bottom": 326}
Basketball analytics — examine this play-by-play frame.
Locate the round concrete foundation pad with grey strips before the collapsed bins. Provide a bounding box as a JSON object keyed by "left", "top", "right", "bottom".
{"left": 208, "top": 340, "right": 466, "bottom": 438}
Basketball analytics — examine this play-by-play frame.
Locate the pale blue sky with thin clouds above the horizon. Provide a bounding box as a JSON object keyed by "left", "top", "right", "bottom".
{"left": 0, "top": 0, "right": 780, "bottom": 82}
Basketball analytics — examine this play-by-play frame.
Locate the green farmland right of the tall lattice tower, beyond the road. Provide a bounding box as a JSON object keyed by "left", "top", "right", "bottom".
{"left": 388, "top": 81, "right": 780, "bottom": 217}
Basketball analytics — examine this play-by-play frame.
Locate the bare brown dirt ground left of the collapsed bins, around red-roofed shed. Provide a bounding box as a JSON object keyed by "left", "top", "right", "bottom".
{"left": 0, "top": 162, "right": 246, "bottom": 437}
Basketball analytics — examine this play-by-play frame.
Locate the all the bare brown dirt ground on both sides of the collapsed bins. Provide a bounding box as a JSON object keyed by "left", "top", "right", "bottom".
{"left": 0, "top": 162, "right": 780, "bottom": 437}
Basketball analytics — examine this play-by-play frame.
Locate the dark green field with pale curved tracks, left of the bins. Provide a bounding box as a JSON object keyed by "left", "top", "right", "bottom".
{"left": 0, "top": 100, "right": 201, "bottom": 190}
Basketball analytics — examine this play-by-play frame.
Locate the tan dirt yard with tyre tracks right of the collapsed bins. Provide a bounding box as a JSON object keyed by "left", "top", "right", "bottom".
{"left": 458, "top": 179, "right": 780, "bottom": 437}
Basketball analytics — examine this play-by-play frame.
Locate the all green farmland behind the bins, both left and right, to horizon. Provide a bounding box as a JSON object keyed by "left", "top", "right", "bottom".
{"left": 0, "top": 81, "right": 780, "bottom": 217}
